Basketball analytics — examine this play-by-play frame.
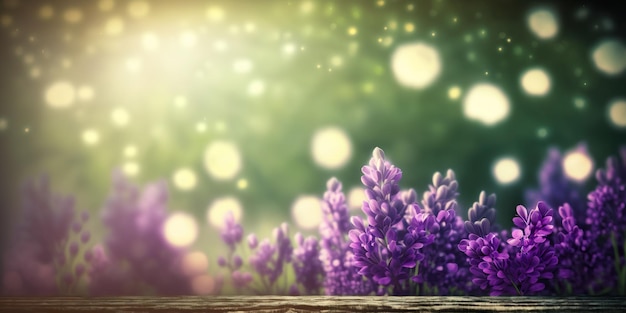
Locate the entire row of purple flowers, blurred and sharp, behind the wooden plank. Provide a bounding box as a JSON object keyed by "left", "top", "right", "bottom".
{"left": 2, "top": 146, "right": 626, "bottom": 296}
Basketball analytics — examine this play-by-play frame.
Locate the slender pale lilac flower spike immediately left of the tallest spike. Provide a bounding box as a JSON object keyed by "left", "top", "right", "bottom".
{"left": 319, "top": 177, "right": 376, "bottom": 295}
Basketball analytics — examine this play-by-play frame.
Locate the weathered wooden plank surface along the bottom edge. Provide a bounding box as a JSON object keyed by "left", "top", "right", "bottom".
{"left": 0, "top": 296, "right": 626, "bottom": 313}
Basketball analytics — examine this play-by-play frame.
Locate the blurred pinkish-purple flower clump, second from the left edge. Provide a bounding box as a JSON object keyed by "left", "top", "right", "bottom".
{"left": 89, "top": 171, "right": 191, "bottom": 295}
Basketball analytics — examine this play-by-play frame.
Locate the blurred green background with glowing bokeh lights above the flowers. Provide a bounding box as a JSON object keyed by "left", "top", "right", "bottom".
{"left": 0, "top": 0, "right": 626, "bottom": 256}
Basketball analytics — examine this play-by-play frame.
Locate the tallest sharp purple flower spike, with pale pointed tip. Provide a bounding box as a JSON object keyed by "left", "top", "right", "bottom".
{"left": 349, "top": 148, "right": 434, "bottom": 295}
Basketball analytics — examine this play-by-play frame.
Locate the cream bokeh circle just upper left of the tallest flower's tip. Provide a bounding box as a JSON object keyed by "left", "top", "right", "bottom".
{"left": 311, "top": 126, "right": 352, "bottom": 169}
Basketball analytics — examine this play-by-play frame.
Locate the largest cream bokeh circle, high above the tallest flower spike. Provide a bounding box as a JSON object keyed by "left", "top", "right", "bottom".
{"left": 391, "top": 42, "right": 441, "bottom": 89}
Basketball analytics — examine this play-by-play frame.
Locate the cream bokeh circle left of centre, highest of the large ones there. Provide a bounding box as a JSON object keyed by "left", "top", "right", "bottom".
{"left": 204, "top": 141, "right": 242, "bottom": 180}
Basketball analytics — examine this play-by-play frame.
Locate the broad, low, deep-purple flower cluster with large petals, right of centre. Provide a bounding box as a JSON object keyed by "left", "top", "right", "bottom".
{"left": 458, "top": 202, "right": 558, "bottom": 295}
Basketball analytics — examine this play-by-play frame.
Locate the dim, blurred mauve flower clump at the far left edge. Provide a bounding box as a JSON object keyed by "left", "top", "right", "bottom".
{"left": 2, "top": 177, "right": 91, "bottom": 296}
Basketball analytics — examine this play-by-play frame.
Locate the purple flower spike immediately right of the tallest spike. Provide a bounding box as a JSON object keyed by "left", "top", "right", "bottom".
{"left": 419, "top": 170, "right": 470, "bottom": 295}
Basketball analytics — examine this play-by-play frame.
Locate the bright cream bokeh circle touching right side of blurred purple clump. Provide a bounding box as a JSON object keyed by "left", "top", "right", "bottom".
{"left": 163, "top": 212, "right": 198, "bottom": 247}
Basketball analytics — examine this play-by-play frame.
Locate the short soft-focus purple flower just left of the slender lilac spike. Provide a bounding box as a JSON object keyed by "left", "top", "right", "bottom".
{"left": 290, "top": 233, "right": 324, "bottom": 295}
